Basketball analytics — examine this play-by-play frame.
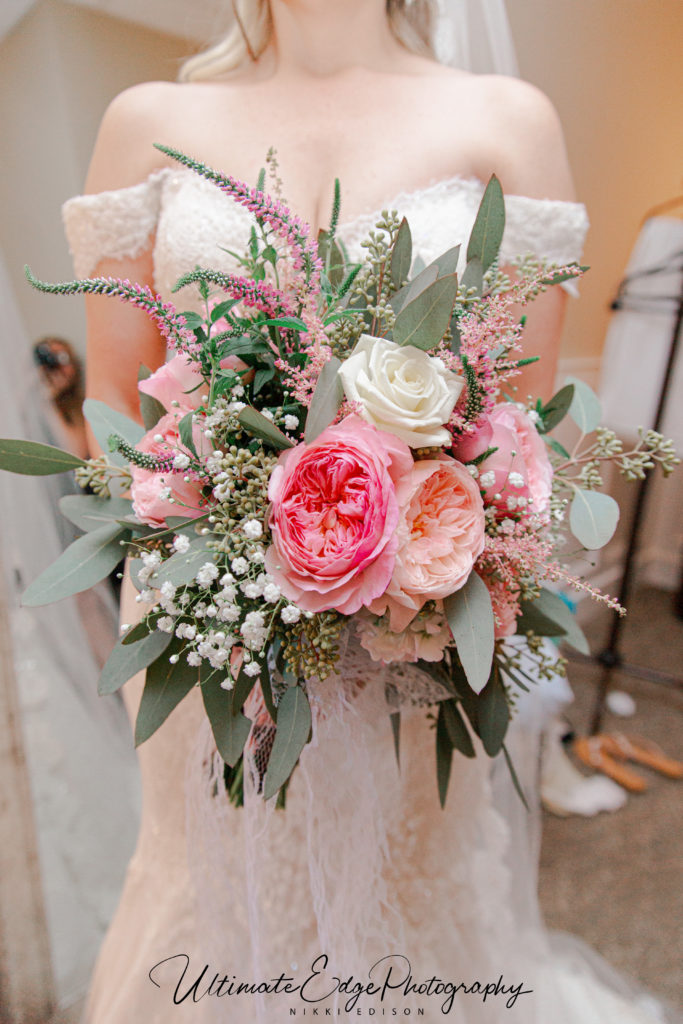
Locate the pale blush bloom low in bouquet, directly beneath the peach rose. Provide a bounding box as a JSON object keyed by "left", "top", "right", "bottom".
{"left": 358, "top": 610, "right": 453, "bottom": 665}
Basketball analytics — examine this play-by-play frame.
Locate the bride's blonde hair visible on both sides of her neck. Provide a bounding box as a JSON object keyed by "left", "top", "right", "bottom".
{"left": 178, "top": 0, "right": 435, "bottom": 82}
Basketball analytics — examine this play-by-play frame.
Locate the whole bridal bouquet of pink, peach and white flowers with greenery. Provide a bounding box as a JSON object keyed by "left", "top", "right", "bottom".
{"left": 0, "top": 150, "right": 677, "bottom": 803}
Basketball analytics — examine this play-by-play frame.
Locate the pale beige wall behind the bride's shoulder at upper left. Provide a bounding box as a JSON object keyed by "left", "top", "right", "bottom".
{"left": 0, "top": 0, "right": 188, "bottom": 348}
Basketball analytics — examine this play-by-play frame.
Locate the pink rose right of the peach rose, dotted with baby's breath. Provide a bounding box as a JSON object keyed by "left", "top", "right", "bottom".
{"left": 454, "top": 401, "right": 553, "bottom": 515}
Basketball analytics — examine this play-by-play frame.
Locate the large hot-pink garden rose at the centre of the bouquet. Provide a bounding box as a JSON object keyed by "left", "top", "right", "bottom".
{"left": 265, "top": 416, "right": 413, "bottom": 615}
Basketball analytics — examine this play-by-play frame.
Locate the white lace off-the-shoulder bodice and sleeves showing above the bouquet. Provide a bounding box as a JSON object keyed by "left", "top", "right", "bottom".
{"left": 63, "top": 168, "right": 588, "bottom": 306}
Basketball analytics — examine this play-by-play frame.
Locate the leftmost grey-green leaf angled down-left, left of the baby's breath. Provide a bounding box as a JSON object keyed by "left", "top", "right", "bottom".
{"left": 22, "top": 522, "right": 130, "bottom": 608}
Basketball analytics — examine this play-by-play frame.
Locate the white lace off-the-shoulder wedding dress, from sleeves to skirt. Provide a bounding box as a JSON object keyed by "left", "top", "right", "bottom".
{"left": 65, "top": 169, "right": 679, "bottom": 1024}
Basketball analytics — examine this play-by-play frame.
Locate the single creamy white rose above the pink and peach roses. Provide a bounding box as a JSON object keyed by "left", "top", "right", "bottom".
{"left": 339, "top": 334, "right": 465, "bottom": 447}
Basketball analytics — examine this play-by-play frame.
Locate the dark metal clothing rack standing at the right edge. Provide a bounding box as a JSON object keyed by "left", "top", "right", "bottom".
{"left": 591, "top": 242, "right": 683, "bottom": 735}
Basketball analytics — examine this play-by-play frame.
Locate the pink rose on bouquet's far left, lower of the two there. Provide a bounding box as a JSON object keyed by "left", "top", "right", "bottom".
{"left": 130, "top": 410, "right": 203, "bottom": 526}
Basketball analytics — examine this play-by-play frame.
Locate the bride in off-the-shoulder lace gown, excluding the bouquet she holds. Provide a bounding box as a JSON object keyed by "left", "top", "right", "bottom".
{"left": 60, "top": 0, "right": 679, "bottom": 1024}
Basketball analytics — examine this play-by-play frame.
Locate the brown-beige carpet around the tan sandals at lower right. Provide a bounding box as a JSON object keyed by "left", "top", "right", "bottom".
{"left": 541, "top": 589, "right": 683, "bottom": 1006}
